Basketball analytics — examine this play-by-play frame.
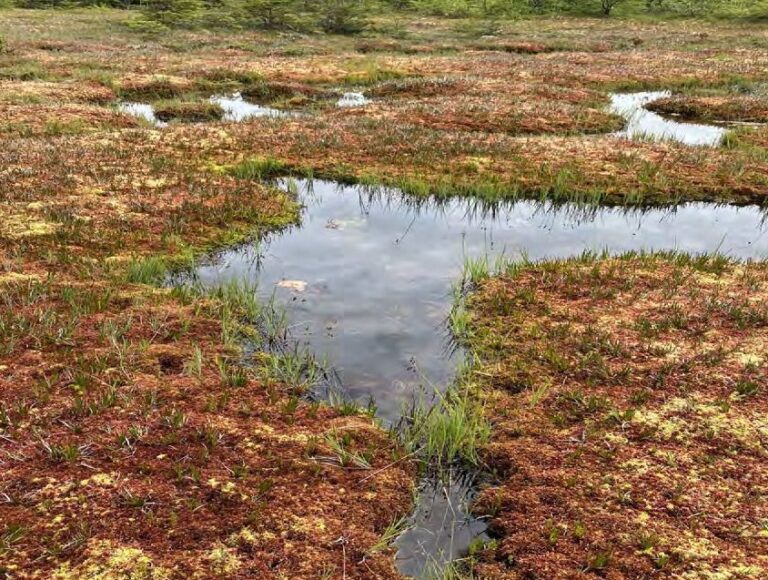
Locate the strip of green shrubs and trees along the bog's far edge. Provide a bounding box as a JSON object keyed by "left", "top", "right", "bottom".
{"left": 11, "top": 0, "right": 768, "bottom": 34}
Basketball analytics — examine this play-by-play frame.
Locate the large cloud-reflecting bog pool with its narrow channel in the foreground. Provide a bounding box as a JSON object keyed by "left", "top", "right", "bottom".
{"left": 186, "top": 180, "right": 768, "bottom": 576}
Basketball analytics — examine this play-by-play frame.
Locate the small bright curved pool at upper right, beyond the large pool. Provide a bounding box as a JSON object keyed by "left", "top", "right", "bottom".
{"left": 610, "top": 91, "right": 726, "bottom": 146}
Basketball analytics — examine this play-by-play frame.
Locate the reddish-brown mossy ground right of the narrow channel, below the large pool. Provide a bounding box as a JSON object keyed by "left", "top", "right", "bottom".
{"left": 469, "top": 255, "right": 768, "bottom": 578}
